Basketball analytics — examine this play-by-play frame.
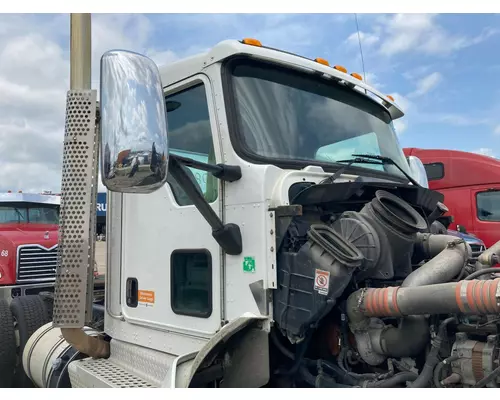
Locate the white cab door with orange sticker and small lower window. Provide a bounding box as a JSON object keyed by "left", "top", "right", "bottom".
{"left": 122, "top": 74, "right": 223, "bottom": 337}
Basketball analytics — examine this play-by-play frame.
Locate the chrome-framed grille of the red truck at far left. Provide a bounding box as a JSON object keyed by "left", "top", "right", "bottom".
{"left": 17, "top": 244, "right": 57, "bottom": 282}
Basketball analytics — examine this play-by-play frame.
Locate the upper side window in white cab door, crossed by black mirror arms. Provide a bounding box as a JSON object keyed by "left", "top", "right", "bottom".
{"left": 165, "top": 83, "right": 218, "bottom": 206}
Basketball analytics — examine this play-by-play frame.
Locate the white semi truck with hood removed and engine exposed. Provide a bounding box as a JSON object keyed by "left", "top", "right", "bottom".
{"left": 17, "top": 15, "right": 500, "bottom": 388}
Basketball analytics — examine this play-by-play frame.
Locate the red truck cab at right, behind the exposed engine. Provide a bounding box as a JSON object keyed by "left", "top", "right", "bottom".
{"left": 403, "top": 148, "right": 500, "bottom": 247}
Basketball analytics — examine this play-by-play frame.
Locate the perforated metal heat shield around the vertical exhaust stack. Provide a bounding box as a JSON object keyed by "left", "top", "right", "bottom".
{"left": 53, "top": 90, "right": 99, "bottom": 328}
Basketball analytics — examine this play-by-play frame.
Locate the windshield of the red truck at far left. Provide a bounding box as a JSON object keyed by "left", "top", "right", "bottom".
{"left": 0, "top": 203, "right": 59, "bottom": 224}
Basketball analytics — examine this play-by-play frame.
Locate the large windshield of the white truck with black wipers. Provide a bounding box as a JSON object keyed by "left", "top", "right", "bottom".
{"left": 229, "top": 60, "right": 410, "bottom": 180}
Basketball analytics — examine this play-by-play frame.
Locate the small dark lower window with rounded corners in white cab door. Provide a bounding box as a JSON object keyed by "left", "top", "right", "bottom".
{"left": 170, "top": 250, "right": 212, "bottom": 318}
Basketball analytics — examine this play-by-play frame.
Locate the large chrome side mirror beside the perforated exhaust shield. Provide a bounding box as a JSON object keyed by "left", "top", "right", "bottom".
{"left": 99, "top": 50, "right": 168, "bottom": 193}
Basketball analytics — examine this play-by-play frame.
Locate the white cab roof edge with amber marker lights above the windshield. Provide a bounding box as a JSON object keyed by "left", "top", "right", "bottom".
{"left": 160, "top": 39, "right": 404, "bottom": 120}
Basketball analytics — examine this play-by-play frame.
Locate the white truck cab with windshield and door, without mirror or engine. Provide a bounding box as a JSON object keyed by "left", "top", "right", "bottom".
{"left": 106, "top": 40, "right": 409, "bottom": 355}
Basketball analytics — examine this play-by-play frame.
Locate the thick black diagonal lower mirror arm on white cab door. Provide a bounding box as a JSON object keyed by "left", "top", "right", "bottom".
{"left": 168, "top": 154, "right": 243, "bottom": 256}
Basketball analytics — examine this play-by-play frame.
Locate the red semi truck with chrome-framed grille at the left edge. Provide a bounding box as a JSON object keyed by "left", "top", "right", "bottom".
{"left": 0, "top": 192, "right": 106, "bottom": 387}
